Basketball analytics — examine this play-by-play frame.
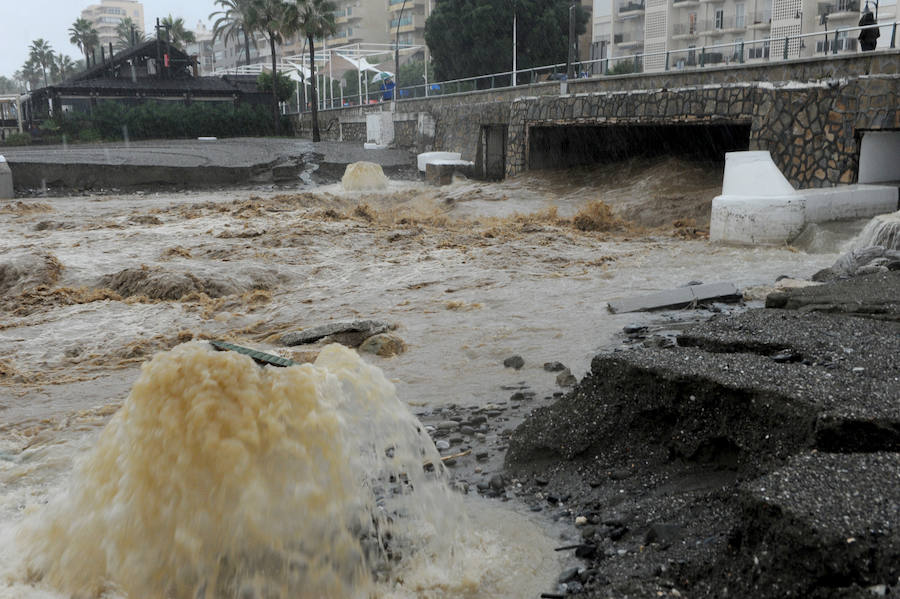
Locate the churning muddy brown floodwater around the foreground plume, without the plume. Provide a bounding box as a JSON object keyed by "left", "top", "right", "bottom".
{"left": 0, "top": 159, "right": 848, "bottom": 597}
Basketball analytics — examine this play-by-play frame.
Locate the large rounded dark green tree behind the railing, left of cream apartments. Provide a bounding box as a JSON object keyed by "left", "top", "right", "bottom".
{"left": 425, "top": 0, "right": 588, "bottom": 79}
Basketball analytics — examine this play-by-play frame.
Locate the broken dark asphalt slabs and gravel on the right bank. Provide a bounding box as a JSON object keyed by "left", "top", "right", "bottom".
{"left": 488, "top": 269, "right": 900, "bottom": 598}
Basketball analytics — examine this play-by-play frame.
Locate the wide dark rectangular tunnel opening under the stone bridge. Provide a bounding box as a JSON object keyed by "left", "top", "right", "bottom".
{"left": 528, "top": 123, "right": 750, "bottom": 169}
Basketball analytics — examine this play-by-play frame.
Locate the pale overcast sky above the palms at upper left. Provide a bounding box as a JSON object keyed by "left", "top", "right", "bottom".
{"left": 0, "top": 0, "right": 218, "bottom": 77}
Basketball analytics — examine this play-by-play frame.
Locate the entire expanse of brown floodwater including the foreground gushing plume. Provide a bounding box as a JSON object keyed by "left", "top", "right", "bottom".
{"left": 0, "top": 159, "right": 837, "bottom": 598}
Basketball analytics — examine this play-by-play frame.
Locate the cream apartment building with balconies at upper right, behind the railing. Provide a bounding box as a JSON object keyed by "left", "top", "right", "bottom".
{"left": 604, "top": 0, "right": 896, "bottom": 72}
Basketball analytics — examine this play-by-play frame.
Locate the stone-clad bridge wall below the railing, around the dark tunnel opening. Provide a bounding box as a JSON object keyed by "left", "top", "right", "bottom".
{"left": 301, "top": 51, "right": 900, "bottom": 188}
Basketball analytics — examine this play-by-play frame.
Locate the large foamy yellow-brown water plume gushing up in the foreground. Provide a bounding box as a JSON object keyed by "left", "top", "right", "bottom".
{"left": 4, "top": 342, "right": 553, "bottom": 599}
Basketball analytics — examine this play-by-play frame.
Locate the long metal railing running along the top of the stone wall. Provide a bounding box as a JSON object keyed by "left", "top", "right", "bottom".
{"left": 292, "top": 21, "right": 900, "bottom": 109}
